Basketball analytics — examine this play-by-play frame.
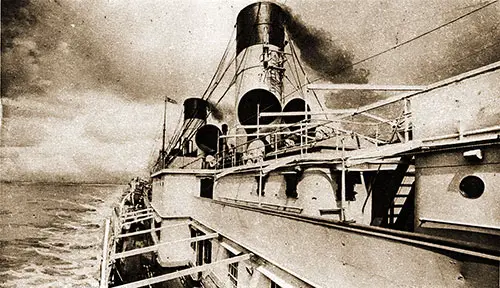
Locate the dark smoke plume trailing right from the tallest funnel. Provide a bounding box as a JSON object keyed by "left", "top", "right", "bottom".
{"left": 284, "top": 8, "right": 370, "bottom": 83}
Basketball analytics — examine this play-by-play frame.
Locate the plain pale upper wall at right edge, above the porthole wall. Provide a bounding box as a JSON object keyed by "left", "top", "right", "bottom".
{"left": 411, "top": 70, "right": 500, "bottom": 139}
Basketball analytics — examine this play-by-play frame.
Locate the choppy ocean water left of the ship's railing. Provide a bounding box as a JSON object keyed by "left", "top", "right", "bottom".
{"left": 0, "top": 183, "right": 125, "bottom": 287}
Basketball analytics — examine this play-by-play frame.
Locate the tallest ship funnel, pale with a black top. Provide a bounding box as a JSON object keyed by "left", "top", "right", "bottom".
{"left": 236, "top": 2, "right": 285, "bottom": 132}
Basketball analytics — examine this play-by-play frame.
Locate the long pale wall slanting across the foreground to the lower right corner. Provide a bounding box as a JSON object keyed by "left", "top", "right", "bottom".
{"left": 191, "top": 198, "right": 499, "bottom": 287}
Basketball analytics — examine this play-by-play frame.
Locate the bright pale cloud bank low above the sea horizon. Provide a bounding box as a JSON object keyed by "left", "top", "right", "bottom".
{"left": 0, "top": 92, "right": 173, "bottom": 182}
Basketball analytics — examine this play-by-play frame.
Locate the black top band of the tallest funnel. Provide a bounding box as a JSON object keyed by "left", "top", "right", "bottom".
{"left": 236, "top": 2, "right": 285, "bottom": 54}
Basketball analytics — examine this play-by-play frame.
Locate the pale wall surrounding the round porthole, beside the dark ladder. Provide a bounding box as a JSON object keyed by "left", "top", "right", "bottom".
{"left": 415, "top": 147, "right": 500, "bottom": 227}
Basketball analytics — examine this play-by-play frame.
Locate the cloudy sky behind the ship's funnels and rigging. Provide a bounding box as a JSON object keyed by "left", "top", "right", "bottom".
{"left": 0, "top": 0, "right": 500, "bottom": 183}
